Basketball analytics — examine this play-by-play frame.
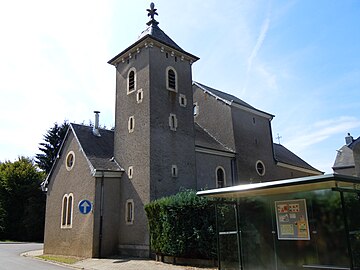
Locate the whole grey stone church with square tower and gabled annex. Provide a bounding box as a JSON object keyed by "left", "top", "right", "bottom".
{"left": 43, "top": 4, "right": 322, "bottom": 257}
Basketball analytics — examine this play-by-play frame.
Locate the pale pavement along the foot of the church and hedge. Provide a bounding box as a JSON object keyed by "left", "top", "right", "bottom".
{"left": 22, "top": 250, "right": 217, "bottom": 270}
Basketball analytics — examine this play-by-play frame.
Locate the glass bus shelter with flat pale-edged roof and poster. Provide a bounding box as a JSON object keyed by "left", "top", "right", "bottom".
{"left": 197, "top": 174, "right": 360, "bottom": 270}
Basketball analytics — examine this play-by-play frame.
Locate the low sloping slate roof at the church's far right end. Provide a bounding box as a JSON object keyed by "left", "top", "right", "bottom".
{"left": 273, "top": 143, "right": 322, "bottom": 173}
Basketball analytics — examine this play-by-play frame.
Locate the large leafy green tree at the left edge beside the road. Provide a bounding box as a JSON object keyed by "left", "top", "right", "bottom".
{"left": 0, "top": 157, "right": 45, "bottom": 241}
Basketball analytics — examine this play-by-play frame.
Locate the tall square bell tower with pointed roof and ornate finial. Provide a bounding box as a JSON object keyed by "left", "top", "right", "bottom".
{"left": 108, "top": 3, "right": 199, "bottom": 256}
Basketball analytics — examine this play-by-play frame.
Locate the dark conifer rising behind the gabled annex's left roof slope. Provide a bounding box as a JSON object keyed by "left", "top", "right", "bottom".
{"left": 35, "top": 121, "right": 69, "bottom": 174}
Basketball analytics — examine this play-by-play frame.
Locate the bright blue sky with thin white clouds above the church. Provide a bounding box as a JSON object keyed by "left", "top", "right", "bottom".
{"left": 0, "top": 0, "right": 360, "bottom": 173}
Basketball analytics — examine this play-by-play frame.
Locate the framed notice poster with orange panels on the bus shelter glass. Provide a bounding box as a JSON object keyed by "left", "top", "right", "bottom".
{"left": 275, "top": 199, "right": 310, "bottom": 240}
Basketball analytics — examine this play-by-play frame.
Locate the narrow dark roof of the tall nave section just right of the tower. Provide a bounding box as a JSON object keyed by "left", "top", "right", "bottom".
{"left": 193, "top": 82, "right": 274, "bottom": 118}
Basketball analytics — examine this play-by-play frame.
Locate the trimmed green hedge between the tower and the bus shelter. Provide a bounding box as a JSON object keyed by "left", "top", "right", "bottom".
{"left": 145, "top": 190, "right": 216, "bottom": 259}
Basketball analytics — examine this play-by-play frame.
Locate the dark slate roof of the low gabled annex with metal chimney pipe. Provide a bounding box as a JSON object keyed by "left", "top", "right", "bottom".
{"left": 70, "top": 124, "right": 123, "bottom": 171}
